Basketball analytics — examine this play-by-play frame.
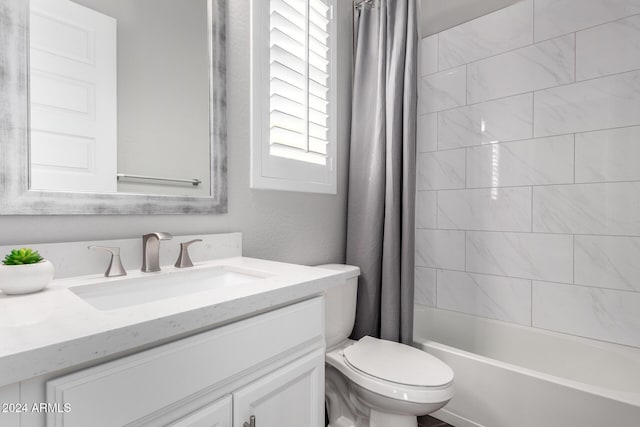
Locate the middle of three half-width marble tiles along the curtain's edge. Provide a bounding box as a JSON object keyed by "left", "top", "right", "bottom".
{"left": 418, "top": 149, "right": 465, "bottom": 190}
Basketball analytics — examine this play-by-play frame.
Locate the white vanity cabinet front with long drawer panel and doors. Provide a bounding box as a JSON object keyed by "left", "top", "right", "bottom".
{"left": 46, "top": 297, "right": 324, "bottom": 427}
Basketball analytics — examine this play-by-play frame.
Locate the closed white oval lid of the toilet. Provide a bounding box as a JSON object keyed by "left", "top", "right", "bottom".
{"left": 344, "top": 336, "right": 453, "bottom": 387}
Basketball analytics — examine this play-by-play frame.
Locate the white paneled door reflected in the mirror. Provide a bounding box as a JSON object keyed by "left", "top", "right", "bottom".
{"left": 30, "top": 0, "right": 117, "bottom": 192}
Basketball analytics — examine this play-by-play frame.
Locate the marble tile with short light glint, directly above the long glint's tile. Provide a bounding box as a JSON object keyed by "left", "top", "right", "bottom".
{"left": 438, "top": 94, "right": 533, "bottom": 149}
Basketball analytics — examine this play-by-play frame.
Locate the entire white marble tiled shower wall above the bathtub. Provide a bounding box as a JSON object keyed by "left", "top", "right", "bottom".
{"left": 416, "top": 0, "right": 640, "bottom": 347}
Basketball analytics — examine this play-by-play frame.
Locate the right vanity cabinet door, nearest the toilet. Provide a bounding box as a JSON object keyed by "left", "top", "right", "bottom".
{"left": 233, "top": 350, "right": 324, "bottom": 427}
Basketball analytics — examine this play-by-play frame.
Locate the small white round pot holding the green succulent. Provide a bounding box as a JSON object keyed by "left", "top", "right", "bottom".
{"left": 0, "top": 260, "right": 53, "bottom": 295}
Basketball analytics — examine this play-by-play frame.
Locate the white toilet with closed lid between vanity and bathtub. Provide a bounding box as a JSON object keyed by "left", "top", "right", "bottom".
{"left": 319, "top": 264, "right": 453, "bottom": 427}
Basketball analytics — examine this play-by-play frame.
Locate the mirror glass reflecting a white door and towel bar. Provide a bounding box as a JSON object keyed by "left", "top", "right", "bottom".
{"left": 30, "top": 0, "right": 212, "bottom": 197}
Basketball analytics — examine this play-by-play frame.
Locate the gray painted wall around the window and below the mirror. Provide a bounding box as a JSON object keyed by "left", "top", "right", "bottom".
{"left": 0, "top": 0, "right": 352, "bottom": 264}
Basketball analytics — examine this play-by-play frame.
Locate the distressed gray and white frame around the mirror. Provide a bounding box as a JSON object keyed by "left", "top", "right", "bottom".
{"left": 0, "top": 0, "right": 227, "bottom": 215}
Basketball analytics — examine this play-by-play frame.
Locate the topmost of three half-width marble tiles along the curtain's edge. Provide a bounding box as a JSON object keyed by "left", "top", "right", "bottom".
{"left": 418, "top": 66, "right": 467, "bottom": 114}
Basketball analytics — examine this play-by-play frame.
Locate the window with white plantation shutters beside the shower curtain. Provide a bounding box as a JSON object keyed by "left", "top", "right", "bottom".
{"left": 251, "top": 0, "right": 336, "bottom": 194}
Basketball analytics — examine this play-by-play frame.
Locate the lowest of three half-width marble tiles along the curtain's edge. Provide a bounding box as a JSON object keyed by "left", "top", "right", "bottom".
{"left": 416, "top": 230, "right": 465, "bottom": 270}
